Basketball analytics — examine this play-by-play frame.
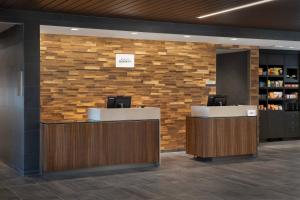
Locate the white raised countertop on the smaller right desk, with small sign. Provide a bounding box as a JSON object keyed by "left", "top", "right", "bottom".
{"left": 191, "top": 105, "right": 257, "bottom": 117}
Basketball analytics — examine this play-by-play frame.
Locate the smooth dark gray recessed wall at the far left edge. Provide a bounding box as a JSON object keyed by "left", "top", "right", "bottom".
{"left": 0, "top": 25, "right": 24, "bottom": 172}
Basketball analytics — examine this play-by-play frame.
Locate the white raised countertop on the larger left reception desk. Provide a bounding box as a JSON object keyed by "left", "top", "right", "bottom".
{"left": 88, "top": 107, "right": 160, "bottom": 121}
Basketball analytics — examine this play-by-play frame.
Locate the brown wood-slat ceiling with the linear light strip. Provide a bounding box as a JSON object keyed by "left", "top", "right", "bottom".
{"left": 0, "top": 0, "right": 300, "bottom": 31}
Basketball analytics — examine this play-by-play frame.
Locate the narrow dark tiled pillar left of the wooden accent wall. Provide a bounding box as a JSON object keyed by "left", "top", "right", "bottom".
{"left": 24, "top": 23, "right": 40, "bottom": 174}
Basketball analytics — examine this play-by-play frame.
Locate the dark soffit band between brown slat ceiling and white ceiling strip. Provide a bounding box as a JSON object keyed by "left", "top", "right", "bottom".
{"left": 0, "top": 9, "right": 300, "bottom": 41}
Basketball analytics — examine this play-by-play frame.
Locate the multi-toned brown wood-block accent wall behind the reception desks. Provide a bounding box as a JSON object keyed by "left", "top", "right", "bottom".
{"left": 40, "top": 34, "right": 258, "bottom": 150}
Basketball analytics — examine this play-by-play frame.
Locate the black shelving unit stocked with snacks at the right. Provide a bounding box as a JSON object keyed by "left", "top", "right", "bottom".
{"left": 259, "top": 50, "right": 300, "bottom": 141}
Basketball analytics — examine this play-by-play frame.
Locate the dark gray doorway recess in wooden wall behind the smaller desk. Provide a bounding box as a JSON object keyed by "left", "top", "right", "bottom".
{"left": 217, "top": 51, "right": 249, "bottom": 105}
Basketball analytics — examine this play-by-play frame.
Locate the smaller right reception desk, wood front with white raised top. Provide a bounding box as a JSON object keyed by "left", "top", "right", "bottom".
{"left": 186, "top": 106, "right": 257, "bottom": 159}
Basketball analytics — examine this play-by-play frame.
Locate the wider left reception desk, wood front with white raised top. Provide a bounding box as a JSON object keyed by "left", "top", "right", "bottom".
{"left": 41, "top": 108, "right": 160, "bottom": 173}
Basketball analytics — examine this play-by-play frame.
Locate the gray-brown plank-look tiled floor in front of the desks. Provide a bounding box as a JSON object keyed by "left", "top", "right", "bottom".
{"left": 0, "top": 141, "right": 300, "bottom": 200}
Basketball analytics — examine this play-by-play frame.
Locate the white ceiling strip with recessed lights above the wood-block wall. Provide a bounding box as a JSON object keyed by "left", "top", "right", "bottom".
{"left": 40, "top": 25, "right": 300, "bottom": 50}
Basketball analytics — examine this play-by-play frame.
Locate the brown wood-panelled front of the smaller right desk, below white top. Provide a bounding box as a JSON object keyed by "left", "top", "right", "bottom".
{"left": 186, "top": 117, "right": 257, "bottom": 158}
